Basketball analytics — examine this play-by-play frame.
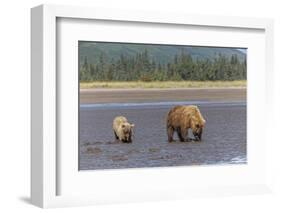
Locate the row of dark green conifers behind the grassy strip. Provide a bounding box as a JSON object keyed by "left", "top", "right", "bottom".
{"left": 79, "top": 50, "right": 247, "bottom": 81}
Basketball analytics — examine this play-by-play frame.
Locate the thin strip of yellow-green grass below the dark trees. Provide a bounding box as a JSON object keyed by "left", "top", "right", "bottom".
{"left": 80, "top": 80, "right": 247, "bottom": 89}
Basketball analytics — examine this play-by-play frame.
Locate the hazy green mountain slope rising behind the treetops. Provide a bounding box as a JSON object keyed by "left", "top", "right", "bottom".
{"left": 79, "top": 41, "right": 246, "bottom": 64}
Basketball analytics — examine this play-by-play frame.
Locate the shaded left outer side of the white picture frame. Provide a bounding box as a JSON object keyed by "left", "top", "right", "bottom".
{"left": 30, "top": 5, "right": 43, "bottom": 207}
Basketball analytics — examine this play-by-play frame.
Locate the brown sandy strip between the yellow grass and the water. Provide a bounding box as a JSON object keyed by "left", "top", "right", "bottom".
{"left": 80, "top": 87, "right": 247, "bottom": 104}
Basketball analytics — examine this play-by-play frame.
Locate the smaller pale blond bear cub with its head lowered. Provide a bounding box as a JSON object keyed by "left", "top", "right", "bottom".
{"left": 112, "top": 116, "right": 135, "bottom": 143}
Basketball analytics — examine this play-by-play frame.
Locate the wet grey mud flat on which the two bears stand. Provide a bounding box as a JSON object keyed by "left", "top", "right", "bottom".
{"left": 79, "top": 101, "right": 247, "bottom": 170}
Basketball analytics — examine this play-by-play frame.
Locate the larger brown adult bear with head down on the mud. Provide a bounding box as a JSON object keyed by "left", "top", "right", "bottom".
{"left": 167, "top": 105, "right": 206, "bottom": 142}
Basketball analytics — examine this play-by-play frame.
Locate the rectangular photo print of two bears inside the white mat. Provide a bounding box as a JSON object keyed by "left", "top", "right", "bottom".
{"left": 78, "top": 41, "right": 247, "bottom": 170}
